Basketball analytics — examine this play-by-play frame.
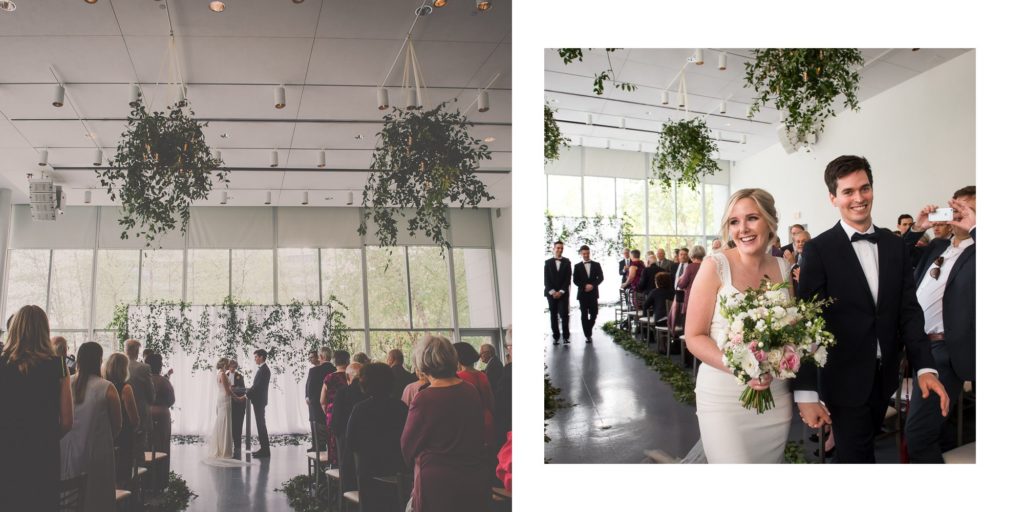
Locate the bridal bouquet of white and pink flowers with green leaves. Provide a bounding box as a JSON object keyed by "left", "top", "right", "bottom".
{"left": 720, "top": 279, "right": 836, "bottom": 414}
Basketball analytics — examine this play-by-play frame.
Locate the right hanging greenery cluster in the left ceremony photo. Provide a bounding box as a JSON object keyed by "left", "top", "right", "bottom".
{"left": 358, "top": 103, "right": 495, "bottom": 249}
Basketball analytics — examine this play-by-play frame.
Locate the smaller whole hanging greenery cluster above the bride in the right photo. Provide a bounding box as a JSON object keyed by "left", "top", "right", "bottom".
{"left": 651, "top": 118, "right": 722, "bottom": 190}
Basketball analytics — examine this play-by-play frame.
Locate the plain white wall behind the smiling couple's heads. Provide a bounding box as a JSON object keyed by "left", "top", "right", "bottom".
{"left": 730, "top": 51, "right": 976, "bottom": 241}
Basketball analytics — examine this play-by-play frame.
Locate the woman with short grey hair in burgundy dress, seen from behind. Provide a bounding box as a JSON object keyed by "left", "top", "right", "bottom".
{"left": 401, "top": 335, "right": 494, "bottom": 512}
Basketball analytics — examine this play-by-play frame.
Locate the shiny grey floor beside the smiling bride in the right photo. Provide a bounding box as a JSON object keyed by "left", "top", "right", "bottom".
{"left": 543, "top": 307, "right": 899, "bottom": 464}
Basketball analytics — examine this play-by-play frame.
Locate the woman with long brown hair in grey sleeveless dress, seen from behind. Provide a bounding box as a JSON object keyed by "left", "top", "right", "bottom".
{"left": 60, "top": 341, "right": 119, "bottom": 511}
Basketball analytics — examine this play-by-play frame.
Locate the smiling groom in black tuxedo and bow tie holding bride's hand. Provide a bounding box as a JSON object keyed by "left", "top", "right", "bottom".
{"left": 794, "top": 156, "right": 949, "bottom": 463}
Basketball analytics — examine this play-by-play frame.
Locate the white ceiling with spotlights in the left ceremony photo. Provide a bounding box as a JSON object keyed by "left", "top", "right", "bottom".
{"left": 0, "top": 0, "right": 512, "bottom": 207}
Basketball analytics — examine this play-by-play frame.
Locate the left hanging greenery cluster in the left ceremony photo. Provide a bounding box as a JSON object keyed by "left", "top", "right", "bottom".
{"left": 96, "top": 100, "right": 228, "bottom": 247}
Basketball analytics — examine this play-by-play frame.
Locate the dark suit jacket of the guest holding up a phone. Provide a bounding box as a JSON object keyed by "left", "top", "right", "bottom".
{"left": 903, "top": 229, "right": 978, "bottom": 381}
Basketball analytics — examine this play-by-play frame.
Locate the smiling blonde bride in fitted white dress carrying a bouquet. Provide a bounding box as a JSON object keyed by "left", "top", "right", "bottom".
{"left": 685, "top": 188, "right": 793, "bottom": 464}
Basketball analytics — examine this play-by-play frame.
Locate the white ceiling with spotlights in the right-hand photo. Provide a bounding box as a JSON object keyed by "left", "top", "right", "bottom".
{"left": 544, "top": 48, "right": 968, "bottom": 161}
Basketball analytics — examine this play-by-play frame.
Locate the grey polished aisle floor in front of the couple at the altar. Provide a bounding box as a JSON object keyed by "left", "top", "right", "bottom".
{"left": 171, "top": 443, "right": 306, "bottom": 512}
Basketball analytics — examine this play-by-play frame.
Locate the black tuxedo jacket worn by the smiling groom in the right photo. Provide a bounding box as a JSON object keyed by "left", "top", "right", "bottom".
{"left": 794, "top": 223, "right": 935, "bottom": 407}
